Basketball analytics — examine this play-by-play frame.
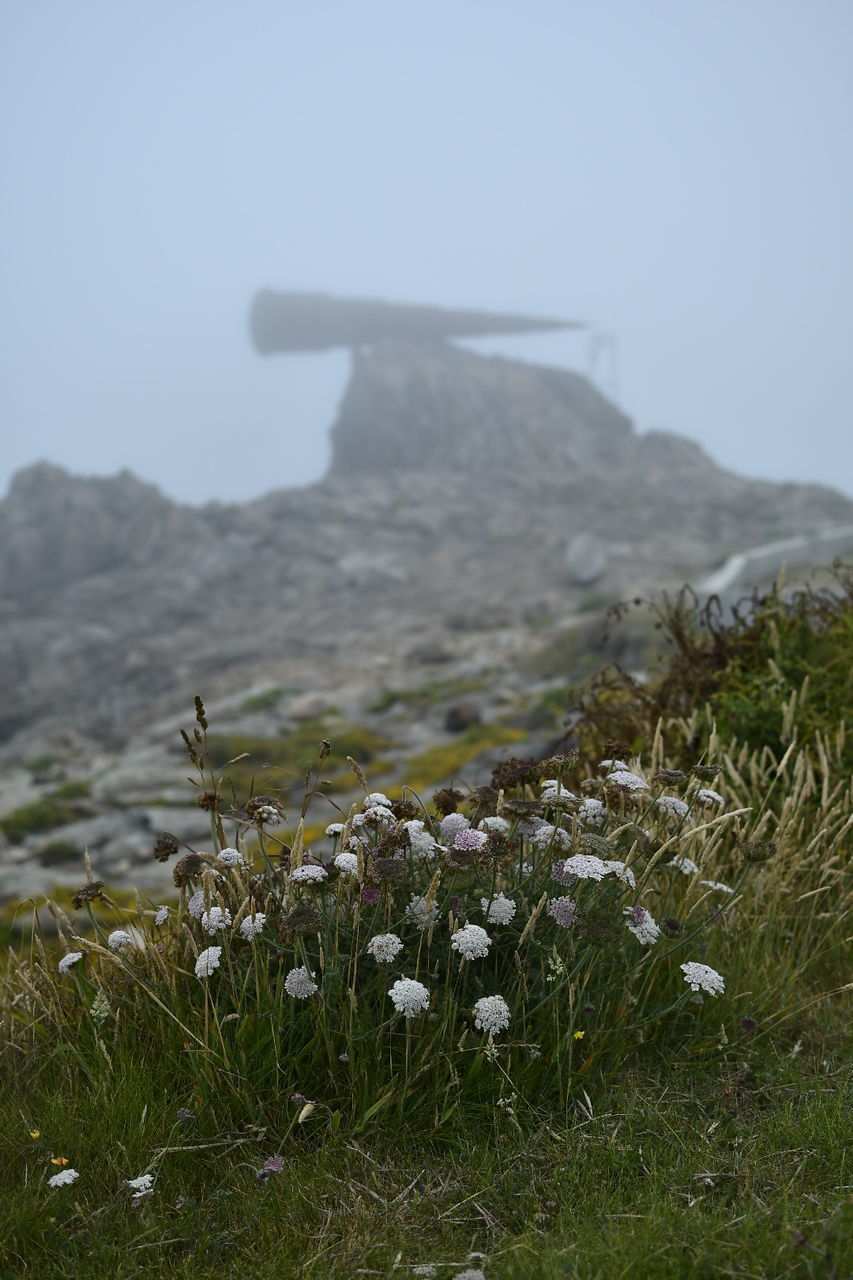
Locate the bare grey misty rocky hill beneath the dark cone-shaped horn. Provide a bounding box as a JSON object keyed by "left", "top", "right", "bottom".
{"left": 0, "top": 342, "right": 853, "bottom": 753}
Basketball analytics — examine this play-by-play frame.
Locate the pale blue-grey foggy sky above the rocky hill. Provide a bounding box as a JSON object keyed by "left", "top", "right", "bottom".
{"left": 0, "top": 0, "right": 853, "bottom": 502}
